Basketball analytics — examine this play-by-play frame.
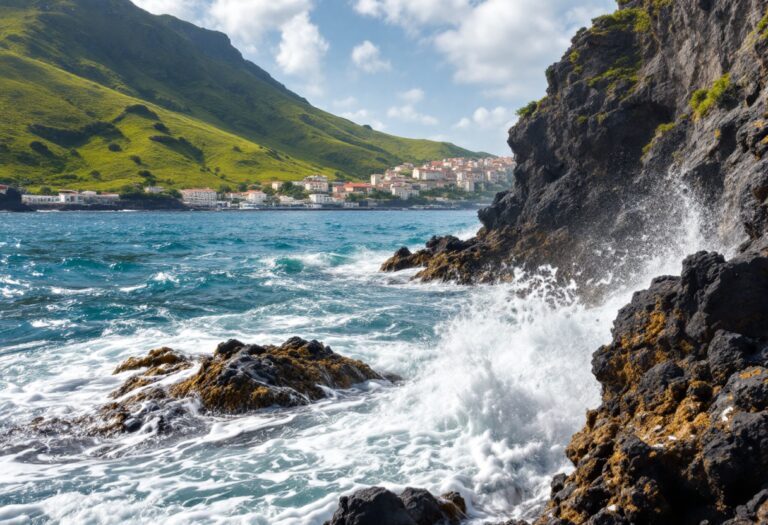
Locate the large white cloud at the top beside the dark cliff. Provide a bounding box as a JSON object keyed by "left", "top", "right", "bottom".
{"left": 354, "top": 0, "right": 615, "bottom": 98}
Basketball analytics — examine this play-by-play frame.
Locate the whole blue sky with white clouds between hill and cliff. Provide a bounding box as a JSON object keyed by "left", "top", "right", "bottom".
{"left": 133, "top": 0, "right": 616, "bottom": 154}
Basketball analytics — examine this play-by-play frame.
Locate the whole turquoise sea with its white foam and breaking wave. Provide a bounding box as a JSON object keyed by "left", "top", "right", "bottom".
{"left": 0, "top": 206, "right": 716, "bottom": 525}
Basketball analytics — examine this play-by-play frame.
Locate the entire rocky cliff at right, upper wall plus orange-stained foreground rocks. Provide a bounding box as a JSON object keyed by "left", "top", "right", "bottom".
{"left": 368, "top": 0, "right": 768, "bottom": 525}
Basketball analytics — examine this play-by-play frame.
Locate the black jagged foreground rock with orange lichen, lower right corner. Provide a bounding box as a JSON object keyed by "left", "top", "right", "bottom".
{"left": 536, "top": 252, "right": 768, "bottom": 525}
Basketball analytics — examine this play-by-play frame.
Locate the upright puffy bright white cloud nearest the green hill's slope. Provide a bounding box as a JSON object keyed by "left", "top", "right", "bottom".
{"left": 275, "top": 11, "right": 329, "bottom": 80}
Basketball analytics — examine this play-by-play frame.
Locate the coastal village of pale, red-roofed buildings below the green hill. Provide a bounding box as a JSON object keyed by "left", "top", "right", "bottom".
{"left": 9, "top": 157, "right": 515, "bottom": 210}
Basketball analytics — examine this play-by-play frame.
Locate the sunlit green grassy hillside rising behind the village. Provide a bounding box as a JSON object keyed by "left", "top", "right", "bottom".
{"left": 0, "top": 0, "right": 480, "bottom": 190}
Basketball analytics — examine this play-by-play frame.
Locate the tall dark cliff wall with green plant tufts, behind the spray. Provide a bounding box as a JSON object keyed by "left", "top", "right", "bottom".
{"left": 384, "top": 0, "right": 768, "bottom": 290}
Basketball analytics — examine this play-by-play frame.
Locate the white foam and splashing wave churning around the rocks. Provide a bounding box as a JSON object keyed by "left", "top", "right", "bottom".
{"left": 0, "top": 179, "right": 724, "bottom": 525}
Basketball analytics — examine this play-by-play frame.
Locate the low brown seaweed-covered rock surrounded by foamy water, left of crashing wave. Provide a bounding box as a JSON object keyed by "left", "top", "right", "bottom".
{"left": 6, "top": 337, "right": 388, "bottom": 436}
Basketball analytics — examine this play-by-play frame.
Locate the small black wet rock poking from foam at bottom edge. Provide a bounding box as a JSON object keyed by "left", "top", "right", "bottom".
{"left": 325, "top": 487, "right": 467, "bottom": 525}
